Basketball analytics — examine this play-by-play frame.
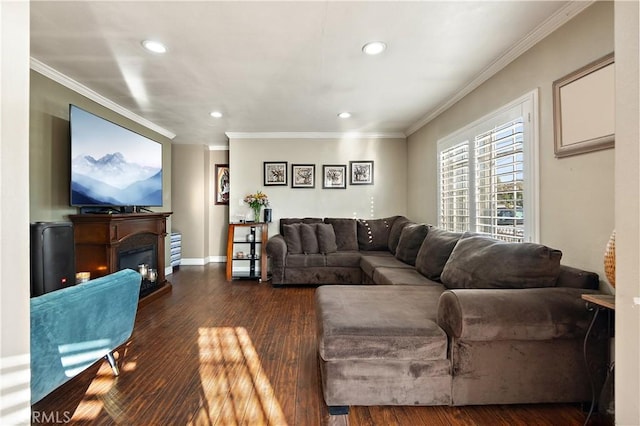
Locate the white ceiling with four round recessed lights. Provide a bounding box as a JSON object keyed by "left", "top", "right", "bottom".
{"left": 31, "top": 1, "right": 590, "bottom": 145}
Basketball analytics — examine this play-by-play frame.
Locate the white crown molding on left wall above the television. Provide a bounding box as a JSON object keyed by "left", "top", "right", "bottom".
{"left": 30, "top": 57, "right": 176, "bottom": 139}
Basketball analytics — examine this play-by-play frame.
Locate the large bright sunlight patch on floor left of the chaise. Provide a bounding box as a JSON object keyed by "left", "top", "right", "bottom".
{"left": 189, "top": 327, "right": 287, "bottom": 426}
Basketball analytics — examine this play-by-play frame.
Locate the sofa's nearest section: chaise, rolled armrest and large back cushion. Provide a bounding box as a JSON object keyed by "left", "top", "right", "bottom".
{"left": 316, "top": 235, "right": 607, "bottom": 414}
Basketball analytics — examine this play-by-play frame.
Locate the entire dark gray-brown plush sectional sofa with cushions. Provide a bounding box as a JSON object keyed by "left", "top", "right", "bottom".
{"left": 267, "top": 216, "right": 607, "bottom": 414}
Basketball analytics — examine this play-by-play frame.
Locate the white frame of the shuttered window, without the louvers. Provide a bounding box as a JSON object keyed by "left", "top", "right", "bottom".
{"left": 437, "top": 89, "right": 540, "bottom": 242}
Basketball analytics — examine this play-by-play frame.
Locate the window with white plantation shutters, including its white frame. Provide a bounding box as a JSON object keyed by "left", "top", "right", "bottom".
{"left": 438, "top": 93, "right": 537, "bottom": 242}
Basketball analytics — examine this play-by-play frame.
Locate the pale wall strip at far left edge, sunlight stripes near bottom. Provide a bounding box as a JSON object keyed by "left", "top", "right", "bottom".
{"left": 0, "top": 1, "right": 30, "bottom": 425}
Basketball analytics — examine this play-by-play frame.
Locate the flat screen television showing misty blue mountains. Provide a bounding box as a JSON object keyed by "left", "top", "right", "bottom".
{"left": 69, "top": 105, "right": 162, "bottom": 207}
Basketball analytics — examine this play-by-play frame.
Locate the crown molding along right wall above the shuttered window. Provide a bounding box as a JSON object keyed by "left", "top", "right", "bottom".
{"left": 405, "top": 0, "right": 595, "bottom": 136}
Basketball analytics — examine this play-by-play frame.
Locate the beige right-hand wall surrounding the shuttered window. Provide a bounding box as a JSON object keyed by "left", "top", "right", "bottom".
{"left": 408, "top": 2, "right": 614, "bottom": 277}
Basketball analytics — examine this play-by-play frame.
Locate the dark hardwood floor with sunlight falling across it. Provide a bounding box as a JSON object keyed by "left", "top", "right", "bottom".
{"left": 32, "top": 264, "right": 596, "bottom": 426}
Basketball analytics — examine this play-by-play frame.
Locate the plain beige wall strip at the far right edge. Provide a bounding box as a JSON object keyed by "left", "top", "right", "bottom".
{"left": 615, "top": 1, "right": 640, "bottom": 425}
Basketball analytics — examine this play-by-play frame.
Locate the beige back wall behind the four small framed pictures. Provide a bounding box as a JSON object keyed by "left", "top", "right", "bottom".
{"left": 229, "top": 137, "right": 407, "bottom": 235}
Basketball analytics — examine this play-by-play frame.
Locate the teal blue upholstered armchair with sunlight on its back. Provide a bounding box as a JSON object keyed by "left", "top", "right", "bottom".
{"left": 31, "top": 269, "right": 141, "bottom": 404}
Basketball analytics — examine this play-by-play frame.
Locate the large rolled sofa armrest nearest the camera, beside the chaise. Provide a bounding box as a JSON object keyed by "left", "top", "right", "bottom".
{"left": 438, "top": 287, "right": 594, "bottom": 341}
